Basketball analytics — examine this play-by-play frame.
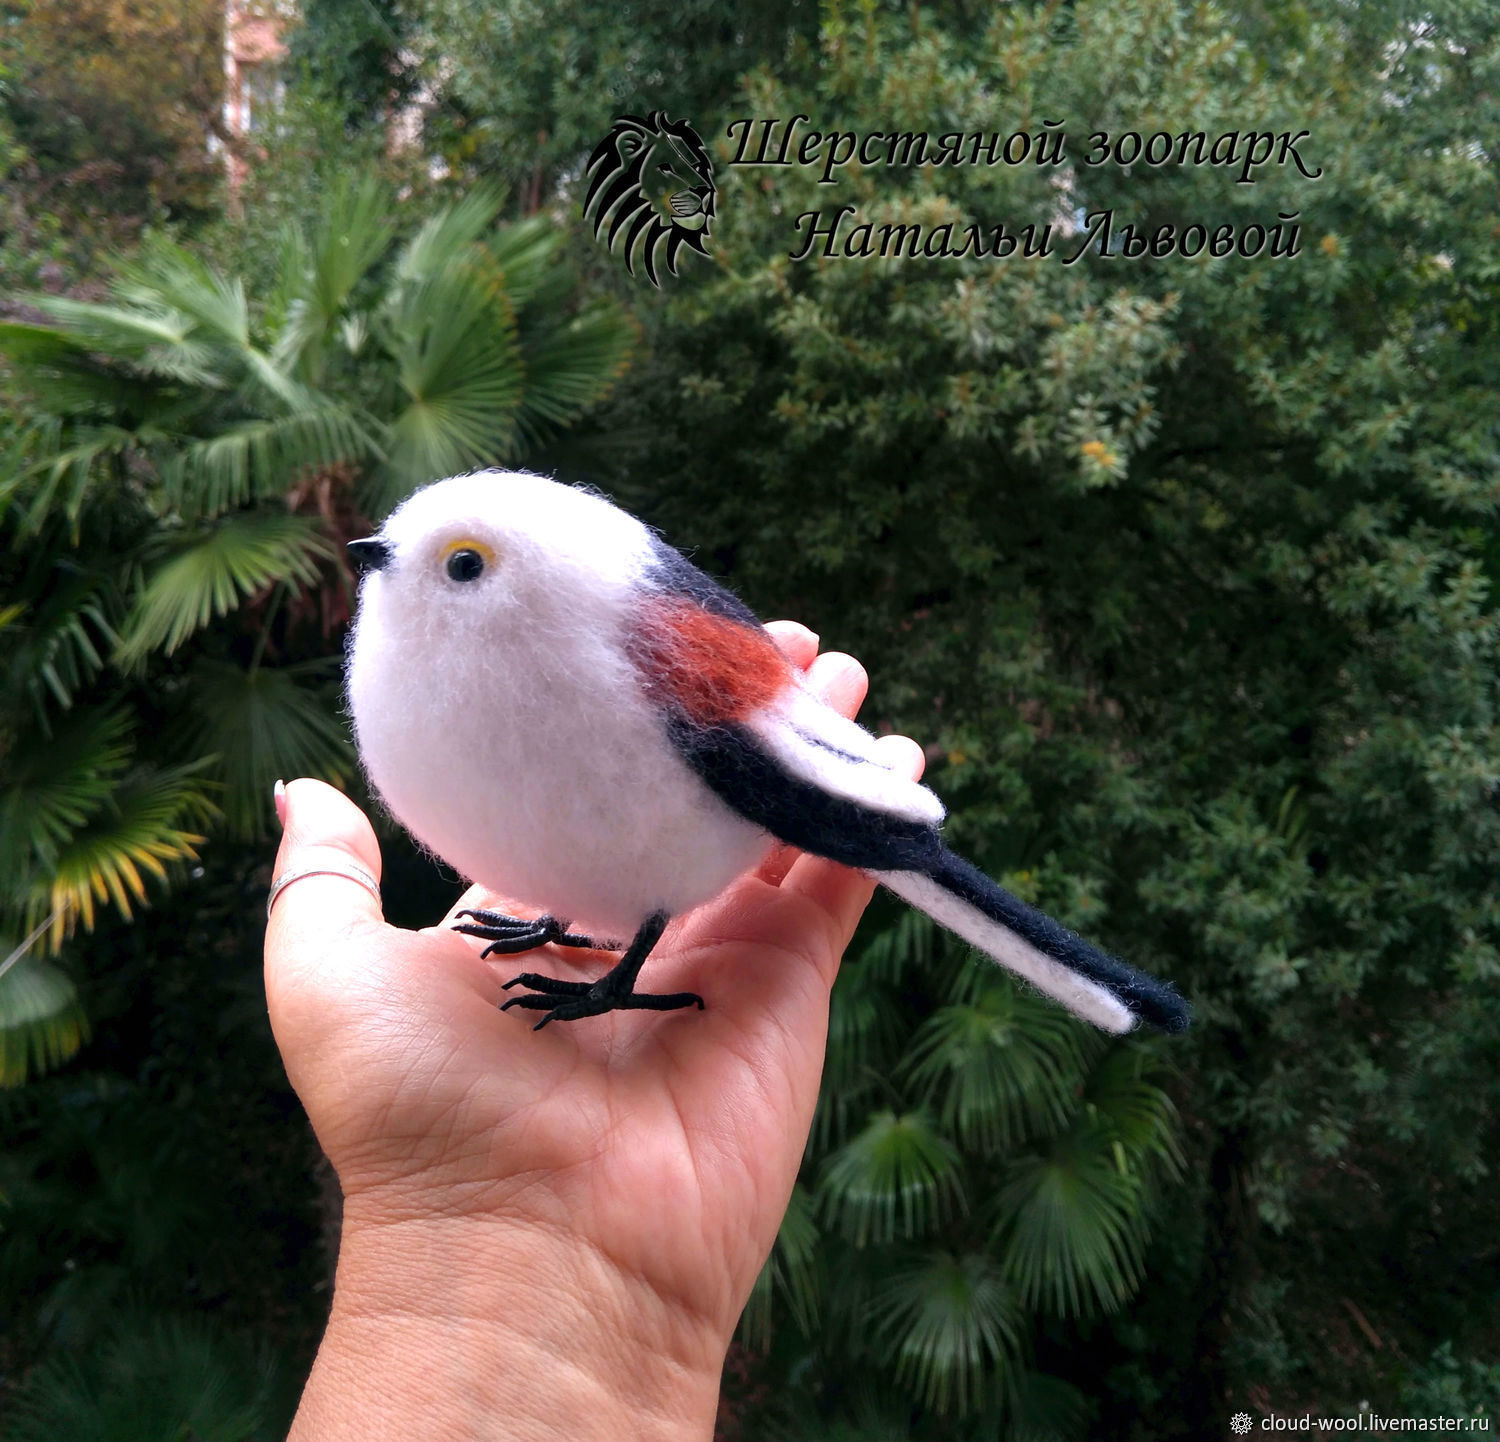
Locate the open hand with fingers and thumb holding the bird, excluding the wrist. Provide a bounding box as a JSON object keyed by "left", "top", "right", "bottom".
{"left": 267, "top": 623, "right": 921, "bottom": 1386}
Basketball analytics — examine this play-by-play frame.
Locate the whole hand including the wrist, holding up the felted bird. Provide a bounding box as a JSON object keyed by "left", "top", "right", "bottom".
{"left": 266, "top": 623, "right": 921, "bottom": 1442}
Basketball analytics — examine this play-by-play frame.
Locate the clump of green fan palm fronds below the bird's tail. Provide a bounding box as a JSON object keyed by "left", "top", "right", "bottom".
{"left": 741, "top": 914, "right": 1182, "bottom": 1437}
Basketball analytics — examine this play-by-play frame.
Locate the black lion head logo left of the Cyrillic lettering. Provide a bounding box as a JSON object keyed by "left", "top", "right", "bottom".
{"left": 584, "top": 110, "right": 714, "bottom": 290}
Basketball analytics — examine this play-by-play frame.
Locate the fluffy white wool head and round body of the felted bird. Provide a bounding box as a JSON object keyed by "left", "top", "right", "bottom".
{"left": 348, "top": 473, "right": 771, "bottom": 941}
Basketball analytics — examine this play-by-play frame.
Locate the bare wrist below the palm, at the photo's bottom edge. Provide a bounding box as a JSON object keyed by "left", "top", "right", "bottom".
{"left": 288, "top": 1211, "right": 729, "bottom": 1442}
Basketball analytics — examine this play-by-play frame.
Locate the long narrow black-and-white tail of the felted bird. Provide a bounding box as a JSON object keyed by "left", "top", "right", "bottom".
{"left": 873, "top": 846, "right": 1188, "bottom": 1032}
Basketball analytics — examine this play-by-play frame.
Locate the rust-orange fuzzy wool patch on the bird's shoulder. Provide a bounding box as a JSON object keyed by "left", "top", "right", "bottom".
{"left": 632, "top": 596, "right": 792, "bottom": 726}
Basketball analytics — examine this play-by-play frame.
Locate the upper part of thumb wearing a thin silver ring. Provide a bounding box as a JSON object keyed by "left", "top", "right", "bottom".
{"left": 266, "top": 779, "right": 383, "bottom": 960}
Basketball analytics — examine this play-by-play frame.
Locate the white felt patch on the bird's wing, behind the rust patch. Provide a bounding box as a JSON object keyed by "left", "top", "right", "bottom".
{"left": 744, "top": 686, "right": 945, "bottom": 825}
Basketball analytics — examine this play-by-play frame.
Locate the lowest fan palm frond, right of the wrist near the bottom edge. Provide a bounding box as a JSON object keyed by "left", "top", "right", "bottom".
{"left": 875, "top": 1251, "right": 1023, "bottom": 1413}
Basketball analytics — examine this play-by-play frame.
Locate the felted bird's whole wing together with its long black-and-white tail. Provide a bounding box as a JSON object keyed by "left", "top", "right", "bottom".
{"left": 633, "top": 542, "right": 1188, "bottom": 1032}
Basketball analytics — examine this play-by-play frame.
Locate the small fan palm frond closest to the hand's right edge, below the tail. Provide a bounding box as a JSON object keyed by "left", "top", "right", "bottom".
{"left": 821, "top": 1112, "right": 965, "bottom": 1247}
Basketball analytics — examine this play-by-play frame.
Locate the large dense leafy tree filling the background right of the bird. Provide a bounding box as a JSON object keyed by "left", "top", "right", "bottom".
{"left": 567, "top": 3, "right": 1500, "bottom": 1437}
